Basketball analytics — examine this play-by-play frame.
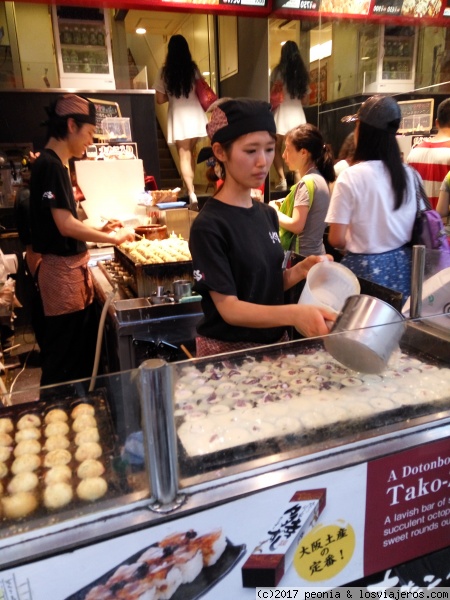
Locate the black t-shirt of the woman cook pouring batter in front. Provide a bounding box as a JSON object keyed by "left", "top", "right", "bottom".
{"left": 189, "top": 198, "right": 285, "bottom": 344}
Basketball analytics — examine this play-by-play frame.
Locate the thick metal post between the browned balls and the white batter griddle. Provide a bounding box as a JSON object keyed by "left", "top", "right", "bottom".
{"left": 139, "top": 358, "right": 184, "bottom": 512}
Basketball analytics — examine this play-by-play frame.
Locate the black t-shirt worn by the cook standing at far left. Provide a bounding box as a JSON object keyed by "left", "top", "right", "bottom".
{"left": 30, "top": 148, "right": 87, "bottom": 256}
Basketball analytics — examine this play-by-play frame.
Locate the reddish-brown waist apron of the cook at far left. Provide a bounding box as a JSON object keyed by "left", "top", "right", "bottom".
{"left": 38, "top": 252, "right": 94, "bottom": 317}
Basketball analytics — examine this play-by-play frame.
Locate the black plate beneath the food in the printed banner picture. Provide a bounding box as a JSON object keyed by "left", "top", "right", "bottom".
{"left": 65, "top": 538, "right": 246, "bottom": 600}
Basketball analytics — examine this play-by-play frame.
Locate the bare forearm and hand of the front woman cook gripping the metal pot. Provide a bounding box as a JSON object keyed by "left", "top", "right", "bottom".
{"left": 210, "top": 292, "right": 336, "bottom": 337}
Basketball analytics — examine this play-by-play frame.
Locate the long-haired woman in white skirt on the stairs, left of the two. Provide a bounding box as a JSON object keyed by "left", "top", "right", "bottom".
{"left": 153, "top": 35, "right": 207, "bottom": 205}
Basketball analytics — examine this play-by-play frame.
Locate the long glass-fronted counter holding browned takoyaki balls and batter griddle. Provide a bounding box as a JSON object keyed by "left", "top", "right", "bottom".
{"left": 0, "top": 308, "right": 450, "bottom": 565}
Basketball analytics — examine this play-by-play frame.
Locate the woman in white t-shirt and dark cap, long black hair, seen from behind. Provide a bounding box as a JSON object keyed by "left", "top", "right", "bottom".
{"left": 326, "top": 96, "right": 417, "bottom": 300}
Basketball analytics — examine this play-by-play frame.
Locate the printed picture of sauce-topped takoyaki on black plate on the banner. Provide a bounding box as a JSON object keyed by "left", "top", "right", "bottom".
{"left": 66, "top": 528, "right": 246, "bottom": 600}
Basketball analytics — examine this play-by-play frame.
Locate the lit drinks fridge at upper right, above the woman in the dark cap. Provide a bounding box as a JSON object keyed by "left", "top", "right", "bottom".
{"left": 359, "top": 25, "right": 417, "bottom": 93}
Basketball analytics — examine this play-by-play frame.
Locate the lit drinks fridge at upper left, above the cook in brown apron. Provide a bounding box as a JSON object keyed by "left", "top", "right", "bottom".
{"left": 53, "top": 6, "right": 115, "bottom": 89}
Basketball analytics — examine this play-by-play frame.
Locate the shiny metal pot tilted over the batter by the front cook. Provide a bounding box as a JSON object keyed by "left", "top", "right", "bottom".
{"left": 324, "top": 294, "right": 405, "bottom": 373}
